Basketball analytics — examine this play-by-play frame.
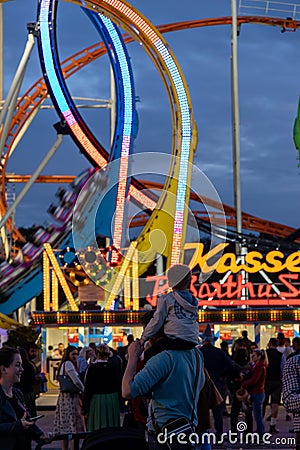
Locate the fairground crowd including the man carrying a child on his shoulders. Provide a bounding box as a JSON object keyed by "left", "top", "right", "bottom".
{"left": 0, "top": 264, "right": 300, "bottom": 450}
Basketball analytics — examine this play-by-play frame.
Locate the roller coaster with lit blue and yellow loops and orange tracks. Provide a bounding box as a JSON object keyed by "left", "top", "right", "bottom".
{"left": 0, "top": 0, "right": 300, "bottom": 324}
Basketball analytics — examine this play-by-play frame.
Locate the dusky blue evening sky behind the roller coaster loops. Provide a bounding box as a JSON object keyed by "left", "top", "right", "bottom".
{"left": 3, "top": 0, "right": 300, "bottom": 228}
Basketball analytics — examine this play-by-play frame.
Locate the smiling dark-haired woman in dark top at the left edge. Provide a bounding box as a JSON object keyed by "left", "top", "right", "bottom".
{"left": 0, "top": 347, "right": 43, "bottom": 450}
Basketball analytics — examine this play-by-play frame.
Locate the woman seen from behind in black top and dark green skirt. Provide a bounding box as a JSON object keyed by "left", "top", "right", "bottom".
{"left": 83, "top": 344, "right": 122, "bottom": 431}
